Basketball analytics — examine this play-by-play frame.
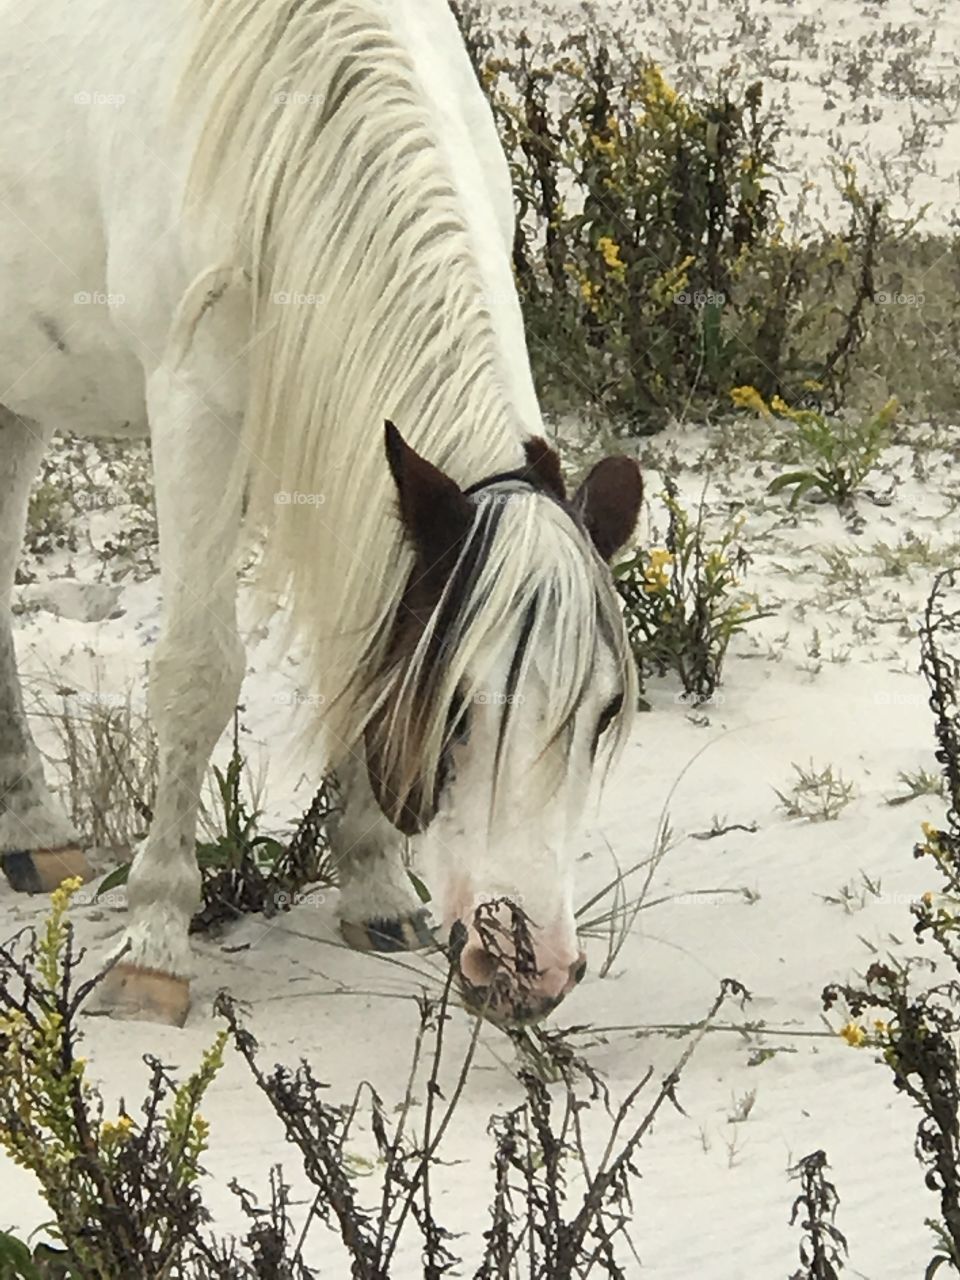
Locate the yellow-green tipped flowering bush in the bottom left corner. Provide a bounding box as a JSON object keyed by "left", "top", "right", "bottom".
{"left": 0, "top": 879, "right": 227, "bottom": 1280}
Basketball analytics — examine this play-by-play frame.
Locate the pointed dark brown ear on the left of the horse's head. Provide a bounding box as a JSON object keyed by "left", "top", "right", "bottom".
{"left": 385, "top": 421, "right": 474, "bottom": 573}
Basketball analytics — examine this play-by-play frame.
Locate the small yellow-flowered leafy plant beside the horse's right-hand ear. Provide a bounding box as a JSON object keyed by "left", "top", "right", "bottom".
{"left": 613, "top": 484, "right": 765, "bottom": 704}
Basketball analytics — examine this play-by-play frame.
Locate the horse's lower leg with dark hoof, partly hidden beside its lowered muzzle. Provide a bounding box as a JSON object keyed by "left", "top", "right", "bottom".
{"left": 333, "top": 748, "right": 435, "bottom": 951}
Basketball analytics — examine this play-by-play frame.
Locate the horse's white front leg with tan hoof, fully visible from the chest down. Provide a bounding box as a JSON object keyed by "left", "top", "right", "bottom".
{"left": 102, "top": 366, "right": 244, "bottom": 1025}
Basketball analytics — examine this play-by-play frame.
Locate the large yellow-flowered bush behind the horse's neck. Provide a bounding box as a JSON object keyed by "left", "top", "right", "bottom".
{"left": 452, "top": 0, "right": 882, "bottom": 431}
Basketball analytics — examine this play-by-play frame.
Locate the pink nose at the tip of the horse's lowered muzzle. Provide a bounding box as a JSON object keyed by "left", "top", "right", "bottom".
{"left": 460, "top": 937, "right": 586, "bottom": 1027}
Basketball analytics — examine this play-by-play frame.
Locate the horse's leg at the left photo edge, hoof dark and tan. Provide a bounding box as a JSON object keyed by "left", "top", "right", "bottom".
{"left": 0, "top": 406, "right": 91, "bottom": 893}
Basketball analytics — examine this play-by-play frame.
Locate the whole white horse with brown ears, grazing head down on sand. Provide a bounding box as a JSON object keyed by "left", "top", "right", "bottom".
{"left": 0, "top": 0, "right": 641, "bottom": 1021}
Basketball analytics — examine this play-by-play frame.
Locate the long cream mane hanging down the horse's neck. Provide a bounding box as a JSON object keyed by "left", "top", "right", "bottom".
{"left": 180, "top": 0, "right": 535, "bottom": 744}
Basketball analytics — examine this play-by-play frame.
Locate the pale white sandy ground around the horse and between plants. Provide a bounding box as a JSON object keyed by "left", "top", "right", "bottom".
{"left": 0, "top": 0, "right": 960, "bottom": 1280}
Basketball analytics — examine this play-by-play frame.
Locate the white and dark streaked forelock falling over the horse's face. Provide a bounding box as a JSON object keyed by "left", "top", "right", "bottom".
{"left": 381, "top": 484, "right": 636, "bottom": 817}
